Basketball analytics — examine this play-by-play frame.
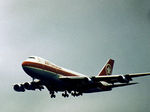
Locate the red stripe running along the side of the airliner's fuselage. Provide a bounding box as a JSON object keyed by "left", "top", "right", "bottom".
{"left": 22, "top": 61, "right": 78, "bottom": 76}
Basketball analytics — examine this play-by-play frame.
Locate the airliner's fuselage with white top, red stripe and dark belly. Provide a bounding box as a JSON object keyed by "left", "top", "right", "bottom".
{"left": 22, "top": 57, "right": 101, "bottom": 93}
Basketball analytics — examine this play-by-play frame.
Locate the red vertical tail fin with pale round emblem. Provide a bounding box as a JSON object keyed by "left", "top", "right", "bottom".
{"left": 98, "top": 59, "right": 114, "bottom": 76}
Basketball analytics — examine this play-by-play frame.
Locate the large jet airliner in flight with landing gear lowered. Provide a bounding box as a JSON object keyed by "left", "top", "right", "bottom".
{"left": 13, "top": 56, "right": 150, "bottom": 98}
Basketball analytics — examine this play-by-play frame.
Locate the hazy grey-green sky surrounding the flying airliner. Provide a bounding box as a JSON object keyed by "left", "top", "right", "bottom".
{"left": 0, "top": 0, "right": 150, "bottom": 112}
